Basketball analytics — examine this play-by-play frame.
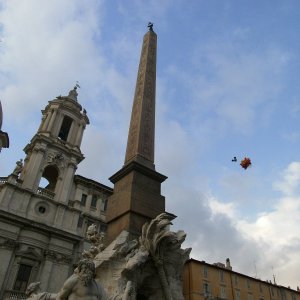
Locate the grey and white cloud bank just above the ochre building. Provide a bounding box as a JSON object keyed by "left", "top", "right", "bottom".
{"left": 164, "top": 162, "right": 300, "bottom": 289}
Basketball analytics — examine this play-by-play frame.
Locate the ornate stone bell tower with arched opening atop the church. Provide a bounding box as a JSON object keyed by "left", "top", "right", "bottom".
{"left": 19, "top": 85, "right": 89, "bottom": 203}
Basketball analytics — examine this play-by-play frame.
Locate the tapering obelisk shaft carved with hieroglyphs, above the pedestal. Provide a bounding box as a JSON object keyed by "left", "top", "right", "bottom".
{"left": 125, "top": 28, "right": 157, "bottom": 168}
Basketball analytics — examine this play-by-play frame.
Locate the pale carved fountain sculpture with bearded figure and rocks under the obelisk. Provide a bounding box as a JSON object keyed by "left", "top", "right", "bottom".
{"left": 28, "top": 213, "right": 191, "bottom": 300}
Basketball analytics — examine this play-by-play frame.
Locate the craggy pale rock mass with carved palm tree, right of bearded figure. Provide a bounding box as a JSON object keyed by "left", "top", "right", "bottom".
{"left": 94, "top": 213, "right": 191, "bottom": 300}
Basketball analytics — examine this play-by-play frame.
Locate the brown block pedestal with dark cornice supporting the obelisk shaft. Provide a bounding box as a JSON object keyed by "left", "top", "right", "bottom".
{"left": 107, "top": 162, "right": 166, "bottom": 242}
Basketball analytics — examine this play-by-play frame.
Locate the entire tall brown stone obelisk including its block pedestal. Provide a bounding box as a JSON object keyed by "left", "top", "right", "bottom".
{"left": 106, "top": 23, "right": 167, "bottom": 243}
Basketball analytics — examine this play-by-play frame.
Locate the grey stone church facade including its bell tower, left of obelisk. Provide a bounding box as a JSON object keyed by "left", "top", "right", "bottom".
{"left": 0, "top": 86, "right": 112, "bottom": 299}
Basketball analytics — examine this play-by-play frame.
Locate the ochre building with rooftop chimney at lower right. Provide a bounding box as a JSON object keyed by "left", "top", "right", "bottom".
{"left": 183, "top": 259, "right": 300, "bottom": 300}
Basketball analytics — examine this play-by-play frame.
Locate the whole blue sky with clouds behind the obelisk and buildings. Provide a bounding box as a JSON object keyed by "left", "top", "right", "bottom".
{"left": 0, "top": 0, "right": 300, "bottom": 289}
